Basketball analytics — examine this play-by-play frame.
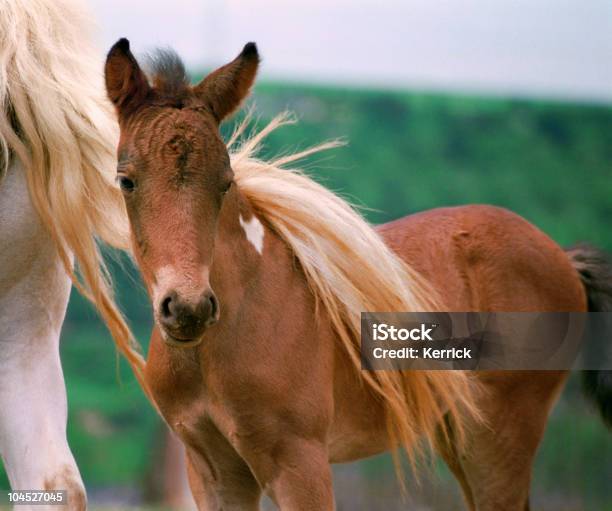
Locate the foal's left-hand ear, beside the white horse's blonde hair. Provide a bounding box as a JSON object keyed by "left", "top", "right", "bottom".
{"left": 104, "top": 38, "right": 151, "bottom": 116}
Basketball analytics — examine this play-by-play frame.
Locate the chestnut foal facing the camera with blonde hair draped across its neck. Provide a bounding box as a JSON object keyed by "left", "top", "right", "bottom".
{"left": 105, "top": 39, "right": 612, "bottom": 511}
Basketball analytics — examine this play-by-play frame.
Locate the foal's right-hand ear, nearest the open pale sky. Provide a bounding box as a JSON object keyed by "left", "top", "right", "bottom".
{"left": 193, "top": 43, "right": 259, "bottom": 122}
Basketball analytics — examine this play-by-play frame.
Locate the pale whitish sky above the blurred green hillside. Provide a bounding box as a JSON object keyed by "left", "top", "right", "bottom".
{"left": 91, "top": 0, "right": 612, "bottom": 103}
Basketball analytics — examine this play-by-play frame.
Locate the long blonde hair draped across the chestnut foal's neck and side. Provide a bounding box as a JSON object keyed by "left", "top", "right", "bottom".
{"left": 228, "top": 114, "right": 476, "bottom": 476}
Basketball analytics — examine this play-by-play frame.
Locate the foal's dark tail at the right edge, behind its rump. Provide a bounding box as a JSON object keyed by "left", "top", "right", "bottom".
{"left": 567, "top": 245, "right": 612, "bottom": 428}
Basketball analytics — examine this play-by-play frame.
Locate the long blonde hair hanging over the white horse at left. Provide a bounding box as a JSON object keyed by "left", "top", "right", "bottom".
{"left": 0, "top": 0, "right": 144, "bottom": 390}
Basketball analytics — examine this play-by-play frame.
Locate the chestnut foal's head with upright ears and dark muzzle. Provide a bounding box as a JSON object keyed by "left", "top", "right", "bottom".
{"left": 105, "top": 39, "right": 259, "bottom": 346}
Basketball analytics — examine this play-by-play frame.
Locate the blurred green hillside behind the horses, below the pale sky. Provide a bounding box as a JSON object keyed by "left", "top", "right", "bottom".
{"left": 0, "top": 84, "right": 612, "bottom": 511}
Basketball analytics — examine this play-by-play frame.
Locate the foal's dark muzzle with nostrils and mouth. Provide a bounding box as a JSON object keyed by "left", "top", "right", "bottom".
{"left": 157, "top": 289, "right": 219, "bottom": 346}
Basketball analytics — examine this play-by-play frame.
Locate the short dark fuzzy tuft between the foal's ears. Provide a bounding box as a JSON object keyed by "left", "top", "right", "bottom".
{"left": 146, "top": 48, "right": 189, "bottom": 98}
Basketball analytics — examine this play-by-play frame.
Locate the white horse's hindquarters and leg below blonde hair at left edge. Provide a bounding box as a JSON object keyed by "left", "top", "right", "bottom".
{"left": 0, "top": 164, "right": 85, "bottom": 511}
